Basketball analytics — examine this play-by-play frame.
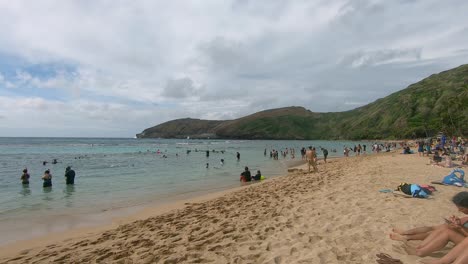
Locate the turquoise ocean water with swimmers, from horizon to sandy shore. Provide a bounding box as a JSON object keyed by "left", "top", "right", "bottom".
{"left": 0, "top": 138, "right": 370, "bottom": 244}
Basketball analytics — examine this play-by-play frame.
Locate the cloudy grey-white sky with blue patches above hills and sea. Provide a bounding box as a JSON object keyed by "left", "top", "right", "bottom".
{"left": 0, "top": 0, "right": 468, "bottom": 137}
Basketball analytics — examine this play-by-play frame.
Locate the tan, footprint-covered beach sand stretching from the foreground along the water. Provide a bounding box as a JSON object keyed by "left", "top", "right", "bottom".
{"left": 0, "top": 153, "right": 466, "bottom": 264}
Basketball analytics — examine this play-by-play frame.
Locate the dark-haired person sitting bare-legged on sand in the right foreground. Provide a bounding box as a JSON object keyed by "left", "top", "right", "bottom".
{"left": 390, "top": 192, "right": 468, "bottom": 257}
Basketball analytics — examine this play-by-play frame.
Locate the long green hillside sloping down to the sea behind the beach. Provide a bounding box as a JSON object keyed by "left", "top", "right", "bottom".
{"left": 137, "top": 65, "right": 468, "bottom": 139}
